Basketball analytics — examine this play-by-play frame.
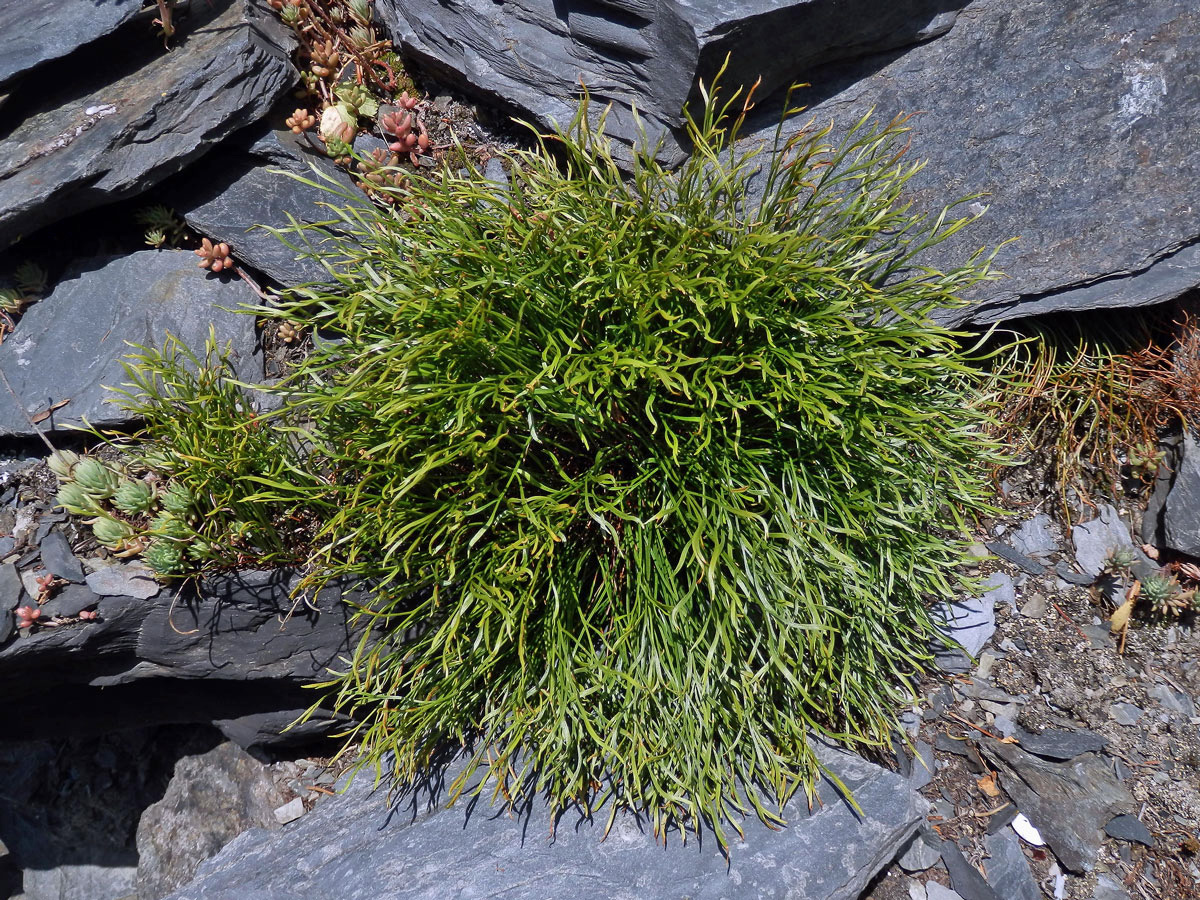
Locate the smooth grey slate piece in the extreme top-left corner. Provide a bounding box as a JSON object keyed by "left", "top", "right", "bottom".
{"left": 0, "top": 0, "right": 142, "bottom": 84}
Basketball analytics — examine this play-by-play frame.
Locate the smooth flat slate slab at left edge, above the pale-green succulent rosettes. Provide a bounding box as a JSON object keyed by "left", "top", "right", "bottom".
{"left": 0, "top": 250, "right": 262, "bottom": 436}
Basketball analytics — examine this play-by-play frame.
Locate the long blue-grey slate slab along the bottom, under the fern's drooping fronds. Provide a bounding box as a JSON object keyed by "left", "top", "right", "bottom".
{"left": 170, "top": 746, "right": 928, "bottom": 900}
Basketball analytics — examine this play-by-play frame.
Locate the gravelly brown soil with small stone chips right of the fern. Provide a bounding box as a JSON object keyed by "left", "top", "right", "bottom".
{"left": 863, "top": 466, "right": 1200, "bottom": 900}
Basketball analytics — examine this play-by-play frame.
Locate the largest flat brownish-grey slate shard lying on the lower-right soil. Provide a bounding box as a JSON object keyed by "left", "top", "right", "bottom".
{"left": 979, "top": 738, "right": 1133, "bottom": 872}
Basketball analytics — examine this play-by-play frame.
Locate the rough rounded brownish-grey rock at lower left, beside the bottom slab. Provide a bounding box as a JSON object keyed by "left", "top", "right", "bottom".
{"left": 137, "top": 743, "right": 284, "bottom": 900}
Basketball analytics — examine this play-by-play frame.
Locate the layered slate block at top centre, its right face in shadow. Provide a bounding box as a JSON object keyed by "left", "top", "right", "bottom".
{"left": 377, "top": 0, "right": 964, "bottom": 162}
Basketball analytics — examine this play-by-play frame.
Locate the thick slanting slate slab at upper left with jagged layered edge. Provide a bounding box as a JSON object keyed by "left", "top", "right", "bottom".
{"left": 0, "top": 0, "right": 295, "bottom": 246}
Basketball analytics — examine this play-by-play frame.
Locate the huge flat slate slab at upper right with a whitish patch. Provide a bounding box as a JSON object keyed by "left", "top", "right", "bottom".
{"left": 746, "top": 0, "right": 1200, "bottom": 323}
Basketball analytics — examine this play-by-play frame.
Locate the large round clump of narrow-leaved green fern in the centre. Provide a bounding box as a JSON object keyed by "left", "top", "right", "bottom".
{"left": 119, "top": 77, "right": 994, "bottom": 840}
